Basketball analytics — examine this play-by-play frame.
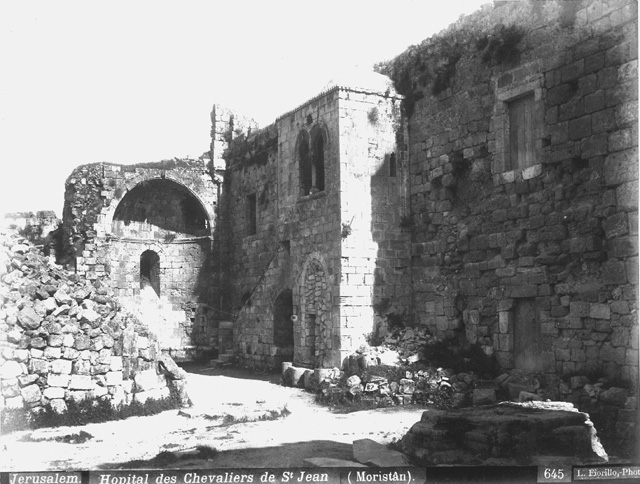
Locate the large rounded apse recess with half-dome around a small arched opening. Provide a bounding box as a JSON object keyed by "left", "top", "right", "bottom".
{"left": 102, "top": 177, "right": 214, "bottom": 308}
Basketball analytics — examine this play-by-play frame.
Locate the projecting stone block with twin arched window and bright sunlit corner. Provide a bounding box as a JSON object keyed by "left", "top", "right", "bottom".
{"left": 222, "top": 74, "right": 410, "bottom": 368}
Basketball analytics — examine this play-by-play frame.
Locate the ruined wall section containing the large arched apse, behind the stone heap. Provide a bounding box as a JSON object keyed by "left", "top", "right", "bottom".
{"left": 63, "top": 160, "right": 219, "bottom": 359}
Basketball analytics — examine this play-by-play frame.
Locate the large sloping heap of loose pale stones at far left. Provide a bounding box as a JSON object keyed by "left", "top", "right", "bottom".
{"left": 0, "top": 229, "right": 188, "bottom": 418}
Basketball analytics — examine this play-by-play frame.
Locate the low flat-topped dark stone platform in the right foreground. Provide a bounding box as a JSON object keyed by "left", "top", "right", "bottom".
{"left": 400, "top": 402, "right": 608, "bottom": 466}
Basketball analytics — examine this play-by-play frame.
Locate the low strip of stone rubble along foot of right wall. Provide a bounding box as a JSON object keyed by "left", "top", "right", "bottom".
{"left": 283, "top": 328, "right": 638, "bottom": 456}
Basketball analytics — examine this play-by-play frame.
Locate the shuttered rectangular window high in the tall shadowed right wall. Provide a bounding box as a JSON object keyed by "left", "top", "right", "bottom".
{"left": 507, "top": 93, "right": 536, "bottom": 170}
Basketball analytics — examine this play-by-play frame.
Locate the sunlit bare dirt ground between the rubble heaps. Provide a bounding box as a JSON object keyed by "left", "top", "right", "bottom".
{"left": 0, "top": 367, "right": 424, "bottom": 471}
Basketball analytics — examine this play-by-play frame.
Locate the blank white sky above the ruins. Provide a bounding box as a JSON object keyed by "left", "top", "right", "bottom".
{"left": 0, "top": 0, "right": 490, "bottom": 216}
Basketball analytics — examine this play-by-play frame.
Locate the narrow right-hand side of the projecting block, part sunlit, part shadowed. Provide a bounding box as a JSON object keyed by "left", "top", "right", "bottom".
{"left": 340, "top": 86, "right": 412, "bottom": 360}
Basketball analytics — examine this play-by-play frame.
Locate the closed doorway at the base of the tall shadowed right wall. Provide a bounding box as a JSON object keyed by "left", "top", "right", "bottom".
{"left": 514, "top": 299, "right": 543, "bottom": 373}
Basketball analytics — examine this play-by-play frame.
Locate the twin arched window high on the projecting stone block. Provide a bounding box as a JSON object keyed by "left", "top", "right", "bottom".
{"left": 297, "top": 126, "right": 326, "bottom": 196}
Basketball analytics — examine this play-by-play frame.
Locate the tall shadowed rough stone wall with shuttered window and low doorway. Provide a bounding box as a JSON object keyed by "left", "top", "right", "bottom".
{"left": 387, "top": 0, "right": 638, "bottom": 383}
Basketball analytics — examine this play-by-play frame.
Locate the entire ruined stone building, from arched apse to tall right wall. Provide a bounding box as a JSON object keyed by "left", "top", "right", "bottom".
{"left": 64, "top": 0, "right": 638, "bottom": 390}
